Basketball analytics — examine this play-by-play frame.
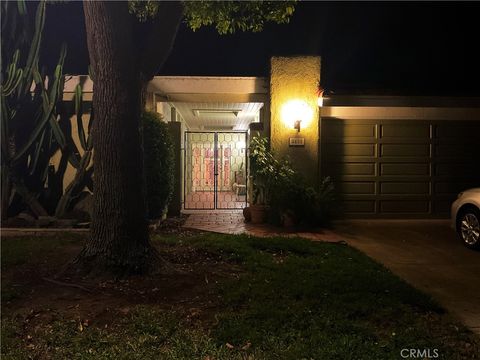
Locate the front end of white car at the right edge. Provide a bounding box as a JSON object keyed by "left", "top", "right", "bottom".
{"left": 452, "top": 188, "right": 480, "bottom": 249}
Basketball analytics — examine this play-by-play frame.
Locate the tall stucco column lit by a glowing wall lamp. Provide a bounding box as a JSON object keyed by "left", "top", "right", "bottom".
{"left": 270, "top": 56, "right": 320, "bottom": 185}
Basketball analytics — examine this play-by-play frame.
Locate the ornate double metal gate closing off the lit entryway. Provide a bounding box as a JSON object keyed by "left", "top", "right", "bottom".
{"left": 183, "top": 131, "right": 247, "bottom": 210}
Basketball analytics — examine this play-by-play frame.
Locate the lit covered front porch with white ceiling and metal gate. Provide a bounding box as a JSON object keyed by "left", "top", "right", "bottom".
{"left": 147, "top": 76, "right": 270, "bottom": 215}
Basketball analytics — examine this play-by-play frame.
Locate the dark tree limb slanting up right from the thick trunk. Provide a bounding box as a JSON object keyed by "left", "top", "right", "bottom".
{"left": 139, "top": 1, "right": 183, "bottom": 81}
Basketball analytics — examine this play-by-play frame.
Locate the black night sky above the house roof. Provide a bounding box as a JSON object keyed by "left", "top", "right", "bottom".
{"left": 45, "top": 1, "right": 480, "bottom": 95}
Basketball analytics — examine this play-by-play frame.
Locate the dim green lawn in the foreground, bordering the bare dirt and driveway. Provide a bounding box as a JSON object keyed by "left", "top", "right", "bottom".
{"left": 2, "top": 234, "right": 478, "bottom": 359}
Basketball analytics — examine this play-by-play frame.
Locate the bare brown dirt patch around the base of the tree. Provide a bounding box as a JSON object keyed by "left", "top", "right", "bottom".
{"left": 2, "top": 221, "right": 241, "bottom": 336}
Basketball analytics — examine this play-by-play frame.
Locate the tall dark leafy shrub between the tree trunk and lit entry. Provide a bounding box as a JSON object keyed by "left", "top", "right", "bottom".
{"left": 142, "top": 112, "right": 174, "bottom": 219}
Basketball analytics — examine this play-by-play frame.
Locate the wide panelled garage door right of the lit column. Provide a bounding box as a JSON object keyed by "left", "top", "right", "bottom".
{"left": 321, "top": 118, "right": 480, "bottom": 218}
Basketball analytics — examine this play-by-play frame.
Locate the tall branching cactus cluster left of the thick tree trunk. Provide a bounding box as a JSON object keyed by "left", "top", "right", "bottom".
{"left": 0, "top": 0, "right": 92, "bottom": 218}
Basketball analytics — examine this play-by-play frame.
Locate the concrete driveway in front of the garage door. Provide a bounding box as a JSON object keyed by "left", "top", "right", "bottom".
{"left": 336, "top": 220, "right": 480, "bottom": 335}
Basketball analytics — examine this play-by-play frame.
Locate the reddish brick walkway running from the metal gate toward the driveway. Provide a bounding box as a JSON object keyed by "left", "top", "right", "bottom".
{"left": 183, "top": 211, "right": 343, "bottom": 242}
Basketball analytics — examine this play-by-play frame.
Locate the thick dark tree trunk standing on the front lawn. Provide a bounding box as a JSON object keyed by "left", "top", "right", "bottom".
{"left": 75, "top": 1, "right": 161, "bottom": 275}
